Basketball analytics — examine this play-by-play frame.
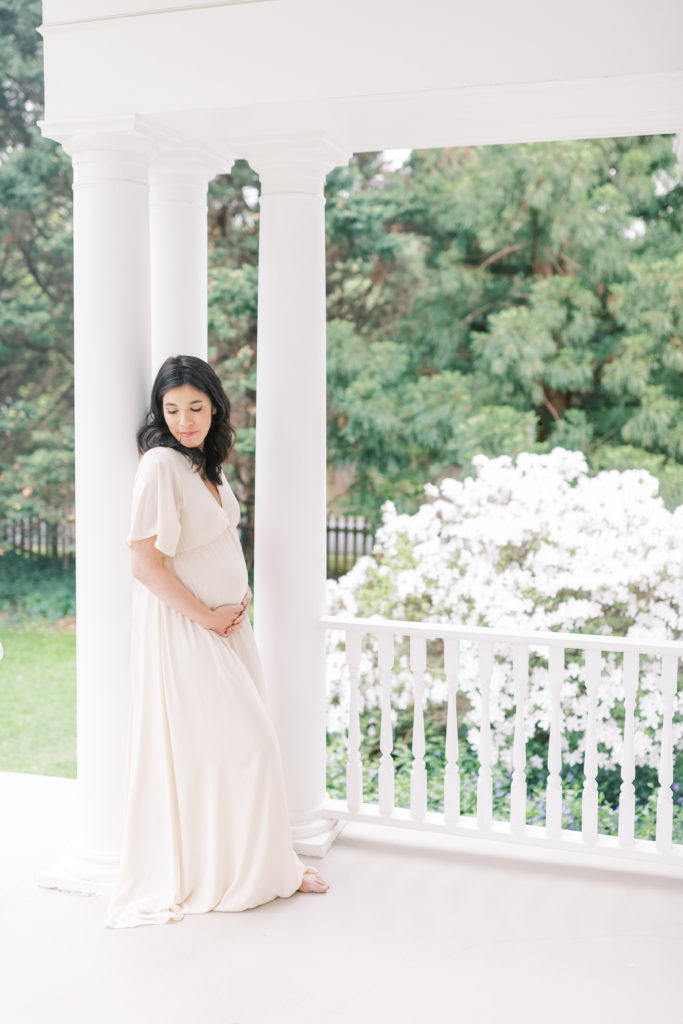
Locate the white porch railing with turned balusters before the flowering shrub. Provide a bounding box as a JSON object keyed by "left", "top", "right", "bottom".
{"left": 321, "top": 616, "right": 683, "bottom": 869}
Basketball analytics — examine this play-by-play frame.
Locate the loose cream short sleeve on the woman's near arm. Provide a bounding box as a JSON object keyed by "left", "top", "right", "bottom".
{"left": 126, "top": 447, "right": 182, "bottom": 557}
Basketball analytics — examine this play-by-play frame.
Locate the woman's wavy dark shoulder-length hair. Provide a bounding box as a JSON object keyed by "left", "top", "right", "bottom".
{"left": 137, "top": 355, "right": 236, "bottom": 485}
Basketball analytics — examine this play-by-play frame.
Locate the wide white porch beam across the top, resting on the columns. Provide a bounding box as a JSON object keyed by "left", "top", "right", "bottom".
{"left": 41, "top": 0, "right": 683, "bottom": 163}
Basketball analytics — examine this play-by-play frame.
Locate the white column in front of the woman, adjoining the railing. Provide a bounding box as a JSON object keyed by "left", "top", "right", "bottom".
{"left": 246, "top": 136, "right": 349, "bottom": 853}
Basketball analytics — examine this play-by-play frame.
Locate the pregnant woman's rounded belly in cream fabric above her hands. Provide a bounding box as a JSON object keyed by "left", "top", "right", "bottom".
{"left": 168, "top": 529, "right": 249, "bottom": 608}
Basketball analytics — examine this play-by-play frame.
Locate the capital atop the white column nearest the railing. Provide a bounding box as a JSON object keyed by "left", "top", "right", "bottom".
{"left": 231, "top": 132, "right": 351, "bottom": 196}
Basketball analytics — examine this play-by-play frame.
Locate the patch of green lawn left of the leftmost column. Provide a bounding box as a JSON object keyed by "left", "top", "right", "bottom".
{"left": 0, "top": 630, "right": 76, "bottom": 778}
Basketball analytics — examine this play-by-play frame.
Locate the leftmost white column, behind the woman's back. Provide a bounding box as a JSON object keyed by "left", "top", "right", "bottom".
{"left": 40, "top": 136, "right": 154, "bottom": 892}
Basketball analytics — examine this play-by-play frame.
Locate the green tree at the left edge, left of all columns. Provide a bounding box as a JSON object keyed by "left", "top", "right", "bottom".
{"left": 0, "top": 0, "right": 74, "bottom": 520}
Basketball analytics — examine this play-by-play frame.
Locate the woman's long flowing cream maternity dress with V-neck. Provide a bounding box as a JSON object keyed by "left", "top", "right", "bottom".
{"left": 106, "top": 447, "right": 304, "bottom": 928}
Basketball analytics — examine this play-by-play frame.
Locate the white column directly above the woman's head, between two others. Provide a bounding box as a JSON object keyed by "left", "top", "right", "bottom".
{"left": 150, "top": 150, "right": 222, "bottom": 377}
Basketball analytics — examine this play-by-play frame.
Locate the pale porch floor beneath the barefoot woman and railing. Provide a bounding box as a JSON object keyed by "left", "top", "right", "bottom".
{"left": 0, "top": 773, "right": 683, "bottom": 1024}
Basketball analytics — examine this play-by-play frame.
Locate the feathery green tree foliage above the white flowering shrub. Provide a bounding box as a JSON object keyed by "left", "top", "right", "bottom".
{"left": 328, "top": 136, "right": 683, "bottom": 512}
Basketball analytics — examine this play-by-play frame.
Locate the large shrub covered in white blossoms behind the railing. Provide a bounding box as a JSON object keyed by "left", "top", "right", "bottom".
{"left": 328, "top": 449, "right": 683, "bottom": 769}
